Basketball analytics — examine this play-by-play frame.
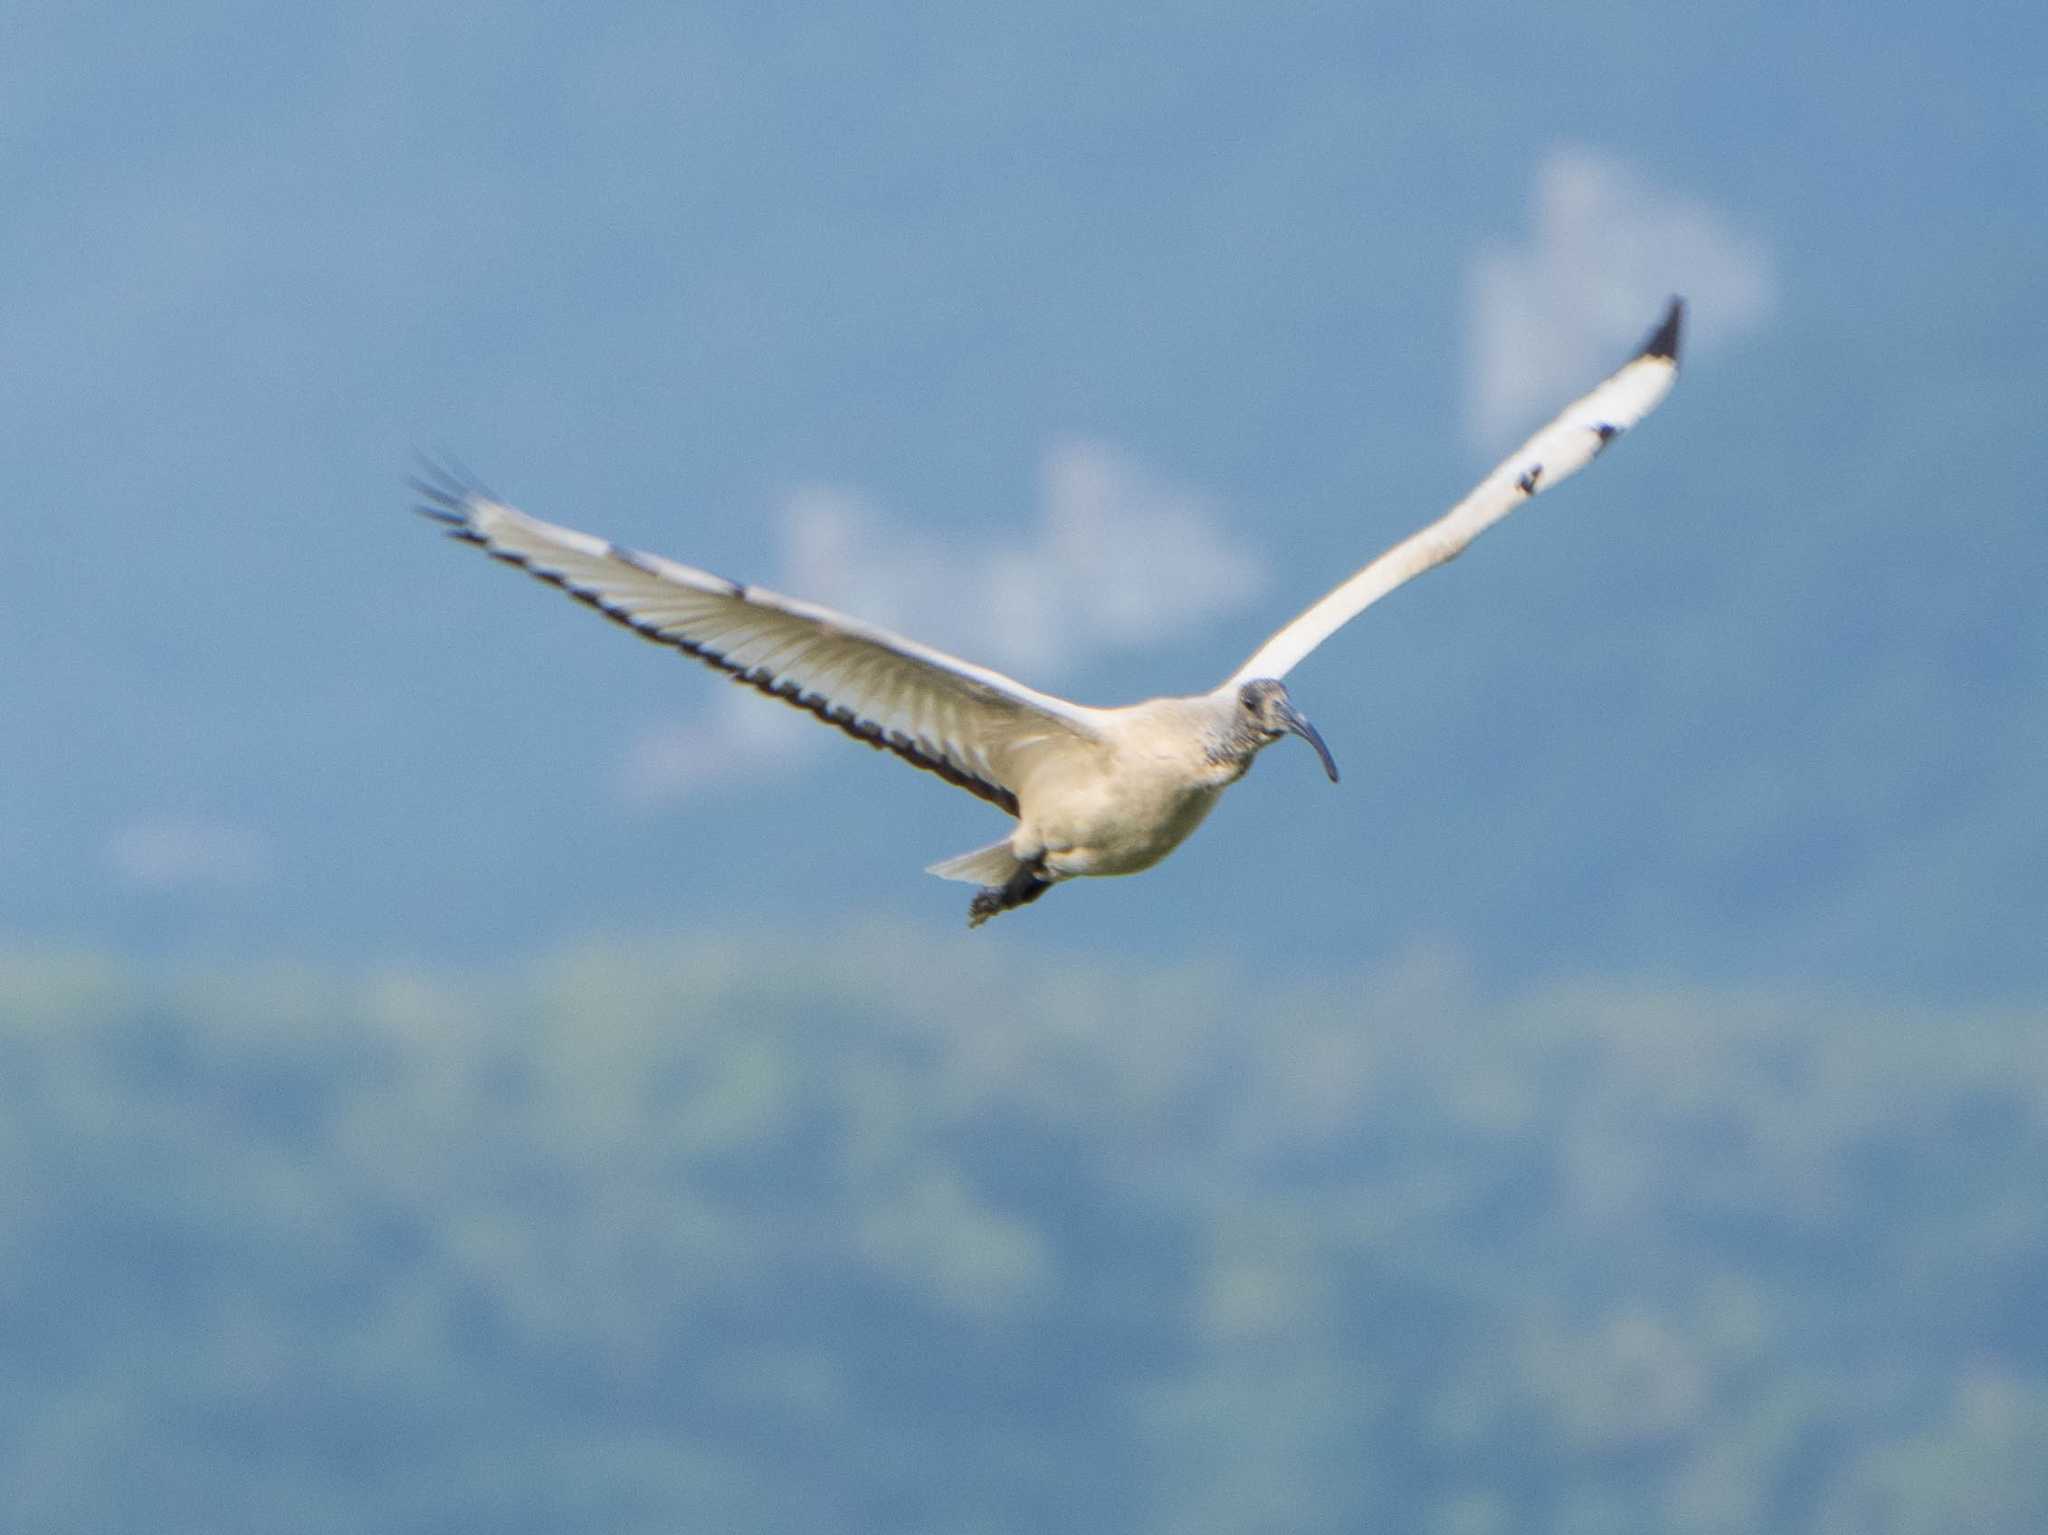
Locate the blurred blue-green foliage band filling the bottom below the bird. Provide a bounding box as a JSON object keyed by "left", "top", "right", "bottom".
{"left": 0, "top": 929, "right": 2048, "bottom": 1535}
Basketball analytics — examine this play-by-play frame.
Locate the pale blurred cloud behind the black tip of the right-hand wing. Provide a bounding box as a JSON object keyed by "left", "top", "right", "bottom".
{"left": 1466, "top": 145, "right": 1778, "bottom": 452}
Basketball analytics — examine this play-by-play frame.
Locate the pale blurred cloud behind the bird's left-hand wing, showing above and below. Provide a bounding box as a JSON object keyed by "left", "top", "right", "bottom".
{"left": 618, "top": 440, "right": 1268, "bottom": 804}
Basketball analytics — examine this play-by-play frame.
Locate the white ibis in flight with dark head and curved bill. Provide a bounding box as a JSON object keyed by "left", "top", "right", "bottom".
{"left": 412, "top": 299, "right": 1686, "bottom": 927}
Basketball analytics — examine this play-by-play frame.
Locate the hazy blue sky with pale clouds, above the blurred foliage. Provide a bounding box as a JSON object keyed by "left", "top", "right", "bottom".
{"left": 0, "top": 4, "right": 2048, "bottom": 999}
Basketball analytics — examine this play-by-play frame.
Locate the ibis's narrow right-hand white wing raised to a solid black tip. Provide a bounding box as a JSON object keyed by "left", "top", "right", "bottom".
{"left": 1225, "top": 299, "right": 1686, "bottom": 688}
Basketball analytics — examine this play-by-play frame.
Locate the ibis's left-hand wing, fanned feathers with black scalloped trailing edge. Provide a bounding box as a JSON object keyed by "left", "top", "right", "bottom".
{"left": 414, "top": 473, "right": 1100, "bottom": 815}
